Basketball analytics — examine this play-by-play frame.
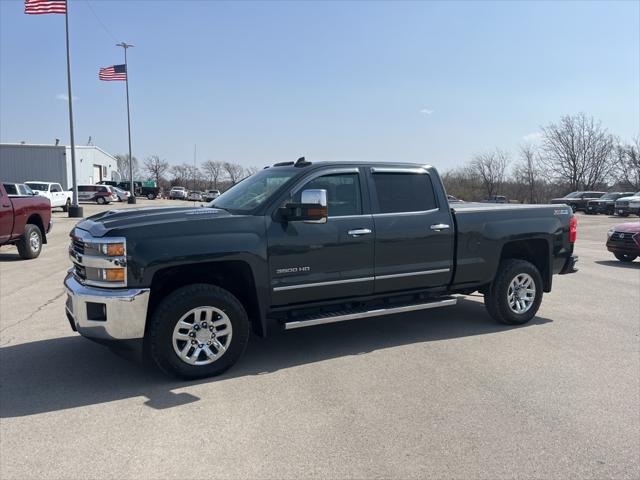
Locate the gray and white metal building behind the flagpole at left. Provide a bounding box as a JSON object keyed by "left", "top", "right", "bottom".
{"left": 0, "top": 143, "right": 120, "bottom": 189}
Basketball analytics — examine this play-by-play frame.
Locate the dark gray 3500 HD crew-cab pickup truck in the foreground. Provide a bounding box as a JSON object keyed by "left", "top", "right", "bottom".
{"left": 65, "top": 159, "right": 576, "bottom": 378}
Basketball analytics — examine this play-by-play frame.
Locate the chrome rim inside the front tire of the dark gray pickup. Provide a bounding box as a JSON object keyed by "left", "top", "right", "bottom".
{"left": 172, "top": 307, "right": 232, "bottom": 365}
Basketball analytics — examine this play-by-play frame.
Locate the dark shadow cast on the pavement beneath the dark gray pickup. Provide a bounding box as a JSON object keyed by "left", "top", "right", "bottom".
{"left": 0, "top": 300, "right": 552, "bottom": 418}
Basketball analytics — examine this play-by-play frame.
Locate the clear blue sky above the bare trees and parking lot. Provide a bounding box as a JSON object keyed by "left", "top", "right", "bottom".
{"left": 0, "top": 0, "right": 640, "bottom": 169}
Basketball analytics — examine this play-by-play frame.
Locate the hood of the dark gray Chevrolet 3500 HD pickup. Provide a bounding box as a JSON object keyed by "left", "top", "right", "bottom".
{"left": 76, "top": 207, "right": 231, "bottom": 237}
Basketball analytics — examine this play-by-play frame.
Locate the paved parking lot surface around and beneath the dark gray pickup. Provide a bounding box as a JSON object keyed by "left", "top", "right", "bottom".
{"left": 0, "top": 200, "right": 640, "bottom": 479}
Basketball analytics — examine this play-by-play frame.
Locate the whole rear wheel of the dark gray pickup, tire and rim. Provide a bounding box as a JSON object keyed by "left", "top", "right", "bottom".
{"left": 484, "top": 259, "right": 542, "bottom": 325}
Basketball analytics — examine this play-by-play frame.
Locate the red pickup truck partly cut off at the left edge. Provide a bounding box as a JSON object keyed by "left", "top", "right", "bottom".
{"left": 0, "top": 182, "right": 51, "bottom": 259}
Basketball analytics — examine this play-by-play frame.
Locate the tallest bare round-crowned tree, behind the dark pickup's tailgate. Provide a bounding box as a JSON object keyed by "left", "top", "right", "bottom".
{"left": 542, "top": 113, "right": 616, "bottom": 190}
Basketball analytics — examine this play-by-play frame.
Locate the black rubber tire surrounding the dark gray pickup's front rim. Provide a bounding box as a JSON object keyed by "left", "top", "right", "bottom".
{"left": 147, "top": 283, "right": 249, "bottom": 379}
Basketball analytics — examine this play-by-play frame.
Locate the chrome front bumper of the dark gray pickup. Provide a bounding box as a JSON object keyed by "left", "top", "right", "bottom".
{"left": 64, "top": 271, "right": 150, "bottom": 340}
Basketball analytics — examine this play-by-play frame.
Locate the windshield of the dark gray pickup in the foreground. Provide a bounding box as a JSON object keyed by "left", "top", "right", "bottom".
{"left": 209, "top": 168, "right": 297, "bottom": 212}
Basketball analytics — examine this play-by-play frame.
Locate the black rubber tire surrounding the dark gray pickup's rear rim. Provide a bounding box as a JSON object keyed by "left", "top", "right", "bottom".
{"left": 484, "top": 259, "right": 542, "bottom": 325}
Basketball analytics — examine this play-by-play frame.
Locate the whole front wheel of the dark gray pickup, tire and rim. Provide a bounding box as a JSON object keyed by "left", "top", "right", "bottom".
{"left": 148, "top": 283, "right": 249, "bottom": 379}
